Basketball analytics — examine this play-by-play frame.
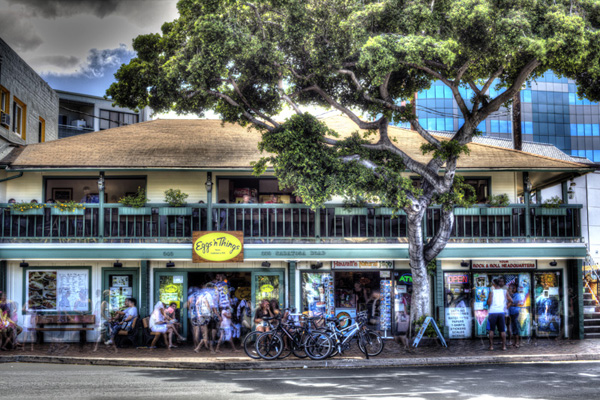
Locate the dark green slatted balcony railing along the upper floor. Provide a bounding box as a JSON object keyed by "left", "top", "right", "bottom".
{"left": 0, "top": 203, "right": 581, "bottom": 243}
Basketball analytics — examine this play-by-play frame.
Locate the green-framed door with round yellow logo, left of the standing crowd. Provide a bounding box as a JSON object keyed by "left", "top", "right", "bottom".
{"left": 155, "top": 271, "right": 188, "bottom": 332}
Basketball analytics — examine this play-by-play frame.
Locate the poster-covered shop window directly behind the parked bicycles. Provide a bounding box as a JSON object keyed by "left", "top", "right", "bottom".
{"left": 302, "top": 272, "right": 335, "bottom": 317}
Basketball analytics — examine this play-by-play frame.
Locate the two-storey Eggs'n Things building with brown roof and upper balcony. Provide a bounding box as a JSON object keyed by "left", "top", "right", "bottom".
{"left": 0, "top": 117, "right": 592, "bottom": 340}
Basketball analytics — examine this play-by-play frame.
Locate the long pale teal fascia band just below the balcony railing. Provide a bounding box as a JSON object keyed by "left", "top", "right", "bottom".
{"left": 2, "top": 243, "right": 587, "bottom": 261}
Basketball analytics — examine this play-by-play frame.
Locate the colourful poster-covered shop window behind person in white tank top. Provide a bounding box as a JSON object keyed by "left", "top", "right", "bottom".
{"left": 473, "top": 272, "right": 531, "bottom": 336}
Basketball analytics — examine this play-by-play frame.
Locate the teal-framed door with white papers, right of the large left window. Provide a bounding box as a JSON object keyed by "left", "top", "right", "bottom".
{"left": 102, "top": 268, "right": 140, "bottom": 312}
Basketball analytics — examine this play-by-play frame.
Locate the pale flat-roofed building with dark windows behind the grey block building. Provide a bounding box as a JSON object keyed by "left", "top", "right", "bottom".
{"left": 56, "top": 90, "right": 152, "bottom": 139}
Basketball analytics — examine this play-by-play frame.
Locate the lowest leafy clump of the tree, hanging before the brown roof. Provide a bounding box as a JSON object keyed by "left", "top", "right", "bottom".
{"left": 254, "top": 114, "right": 422, "bottom": 211}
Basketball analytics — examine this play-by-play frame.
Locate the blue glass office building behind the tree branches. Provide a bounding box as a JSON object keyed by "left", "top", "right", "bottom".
{"left": 402, "top": 72, "right": 600, "bottom": 162}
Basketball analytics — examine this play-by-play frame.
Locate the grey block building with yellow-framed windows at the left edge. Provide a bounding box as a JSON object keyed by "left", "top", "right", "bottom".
{"left": 0, "top": 39, "right": 58, "bottom": 154}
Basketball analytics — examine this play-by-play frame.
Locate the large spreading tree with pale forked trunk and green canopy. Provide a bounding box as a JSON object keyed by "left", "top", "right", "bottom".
{"left": 107, "top": 0, "right": 600, "bottom": 319}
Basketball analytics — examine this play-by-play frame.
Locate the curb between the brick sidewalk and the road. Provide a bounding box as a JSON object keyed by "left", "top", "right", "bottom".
{"left": 0, "top": 354, "right": 600, "bottom": 371}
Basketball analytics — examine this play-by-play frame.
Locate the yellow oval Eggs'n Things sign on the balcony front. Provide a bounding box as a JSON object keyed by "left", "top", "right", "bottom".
{"left": 192, "top": 231, "right": 244, "bottom": 263}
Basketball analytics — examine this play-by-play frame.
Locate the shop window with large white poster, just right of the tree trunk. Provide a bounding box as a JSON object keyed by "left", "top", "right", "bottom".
{"left": 444, "top": 272, "right": 472, "bottom": 339}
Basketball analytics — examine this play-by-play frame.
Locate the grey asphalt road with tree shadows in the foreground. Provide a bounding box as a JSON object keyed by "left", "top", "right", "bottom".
{"left": 0, "top": 362, "right": 600, "bottom": 400}
